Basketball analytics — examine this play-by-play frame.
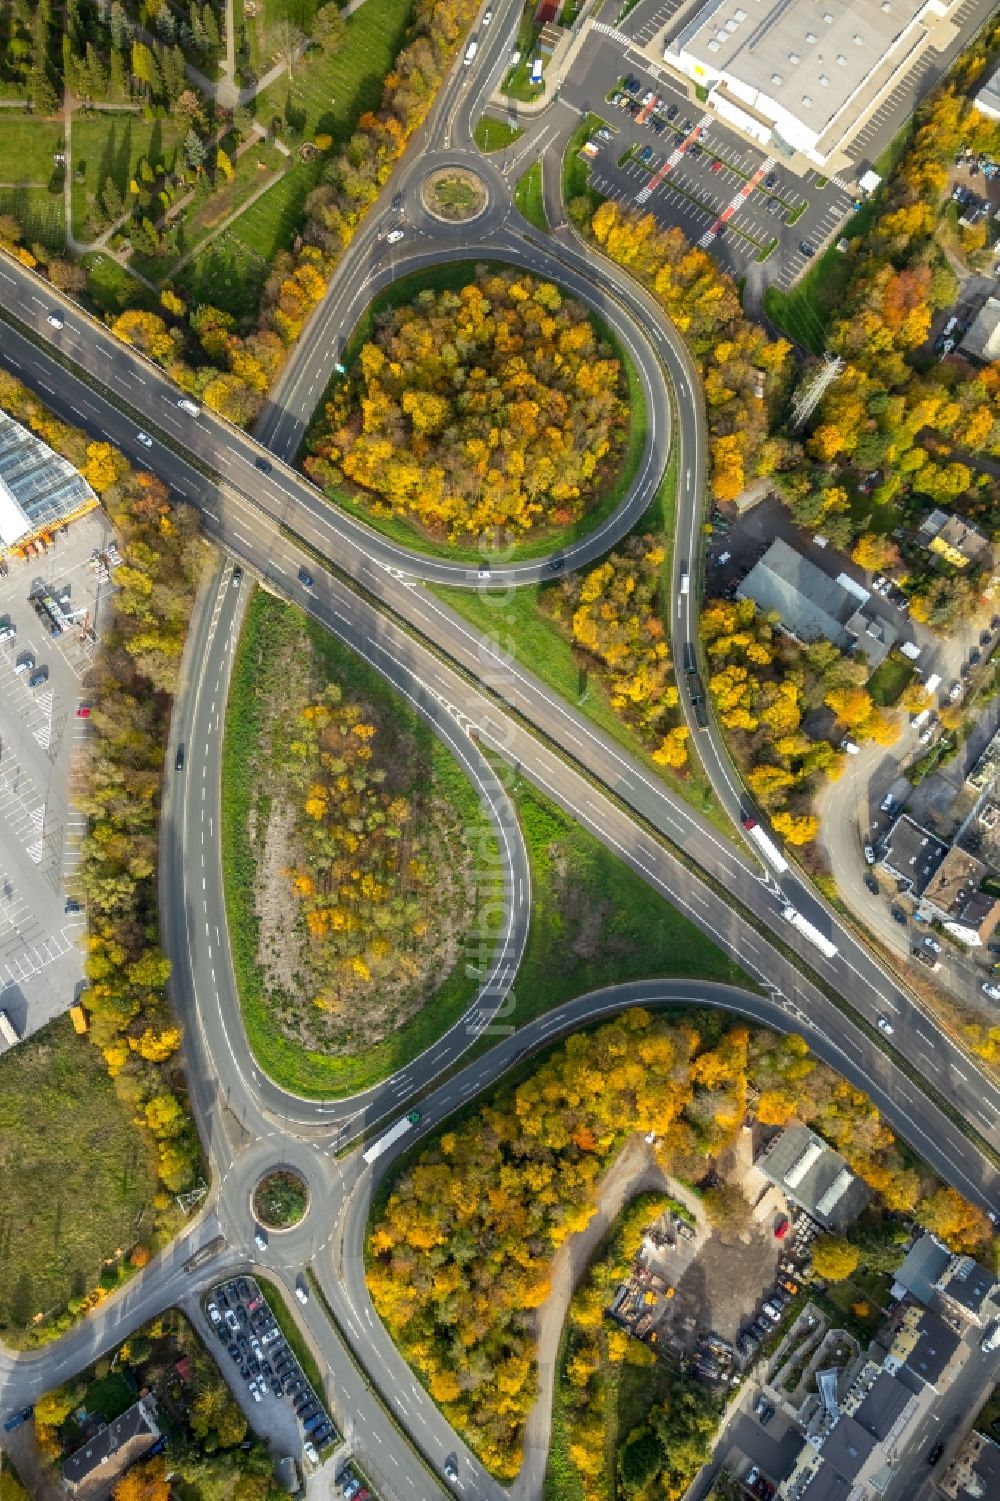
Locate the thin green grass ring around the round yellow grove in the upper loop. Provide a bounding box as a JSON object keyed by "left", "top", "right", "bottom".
{"left": 299, "top": 261, "right": 646, "bottom": 563}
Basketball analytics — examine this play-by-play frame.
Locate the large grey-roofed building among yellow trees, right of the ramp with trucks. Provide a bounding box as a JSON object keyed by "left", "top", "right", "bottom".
{"left": 737, "top": 537, "right": 898, "bottom": 668}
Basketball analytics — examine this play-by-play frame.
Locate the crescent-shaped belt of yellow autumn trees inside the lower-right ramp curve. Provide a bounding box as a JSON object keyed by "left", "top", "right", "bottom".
{"left": 361, "top": 1010, "right": 991, "bottom": 1476}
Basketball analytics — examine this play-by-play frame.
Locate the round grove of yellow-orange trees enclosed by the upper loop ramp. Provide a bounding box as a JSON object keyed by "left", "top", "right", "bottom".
{"left": 305, "top": 266, "right": 628, "bottom": 540}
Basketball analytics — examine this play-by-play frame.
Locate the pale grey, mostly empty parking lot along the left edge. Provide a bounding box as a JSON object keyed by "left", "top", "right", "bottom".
{"left": 0, "top": 510, "right": 113, "bottom": 1036}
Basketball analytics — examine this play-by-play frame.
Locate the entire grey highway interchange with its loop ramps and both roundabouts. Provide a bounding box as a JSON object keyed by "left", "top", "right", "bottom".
{"left": 0, "top": 3, "right": 1000, "bottom": 1501}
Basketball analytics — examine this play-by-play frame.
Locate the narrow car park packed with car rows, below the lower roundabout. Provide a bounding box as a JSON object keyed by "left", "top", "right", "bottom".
{"left": 204, "top": 1277, "right": 341, "bottom": 1468}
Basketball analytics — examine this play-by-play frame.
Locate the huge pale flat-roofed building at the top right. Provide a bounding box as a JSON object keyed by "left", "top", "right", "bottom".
{"left": 664, "top": 0, "right": 958, "bottom": 174}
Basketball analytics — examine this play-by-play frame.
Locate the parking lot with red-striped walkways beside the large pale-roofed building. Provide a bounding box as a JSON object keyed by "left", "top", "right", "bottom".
{"left": 563, "top": 35, "right": 851, "bottom": 288}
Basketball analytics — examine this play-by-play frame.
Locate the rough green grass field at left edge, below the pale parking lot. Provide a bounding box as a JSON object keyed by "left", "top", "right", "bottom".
{"left": 0, "top": 1016, "right": 156, "bottom": 1345}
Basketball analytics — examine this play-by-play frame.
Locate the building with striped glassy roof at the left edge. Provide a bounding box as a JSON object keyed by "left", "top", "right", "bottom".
{"left": 0, "top": 408, "right": 98, "bottom": 552}
